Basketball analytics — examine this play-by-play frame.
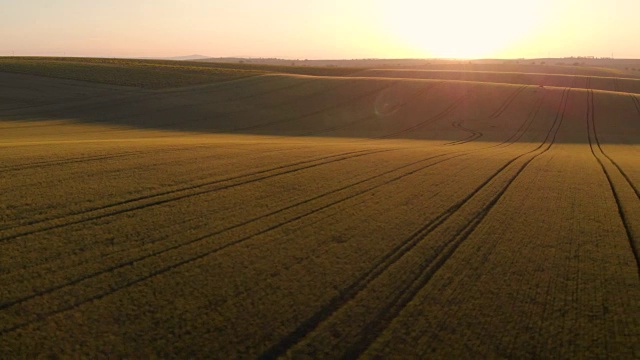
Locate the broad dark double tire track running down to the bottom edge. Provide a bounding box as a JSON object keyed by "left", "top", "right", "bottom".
{"left": 260, "top": 88, "right": 569, "bottom": 359}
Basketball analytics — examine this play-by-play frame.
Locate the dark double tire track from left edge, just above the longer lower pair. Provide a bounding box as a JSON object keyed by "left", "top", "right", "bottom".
{"left": 0, "top": 149, "right": 384, "bottom": 242}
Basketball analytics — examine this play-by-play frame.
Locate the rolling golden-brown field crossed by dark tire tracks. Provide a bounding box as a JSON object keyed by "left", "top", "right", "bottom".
{"left": 0, "top": 66, "right": 640, "bottom": 358}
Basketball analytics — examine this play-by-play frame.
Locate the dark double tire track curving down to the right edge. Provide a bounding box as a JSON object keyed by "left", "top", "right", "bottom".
{"left": 587, "top": 90, "right": 640, "bottom": 275}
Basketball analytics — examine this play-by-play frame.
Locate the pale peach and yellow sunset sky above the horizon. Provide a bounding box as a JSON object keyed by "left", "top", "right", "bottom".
{"left": 0, "top": 0, "right": 640, "bottom": 59}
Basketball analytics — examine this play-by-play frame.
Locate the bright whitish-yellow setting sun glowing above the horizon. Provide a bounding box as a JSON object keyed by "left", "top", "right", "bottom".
{"left": 379, "top": 0, "right": 539, "bottom": 59}
